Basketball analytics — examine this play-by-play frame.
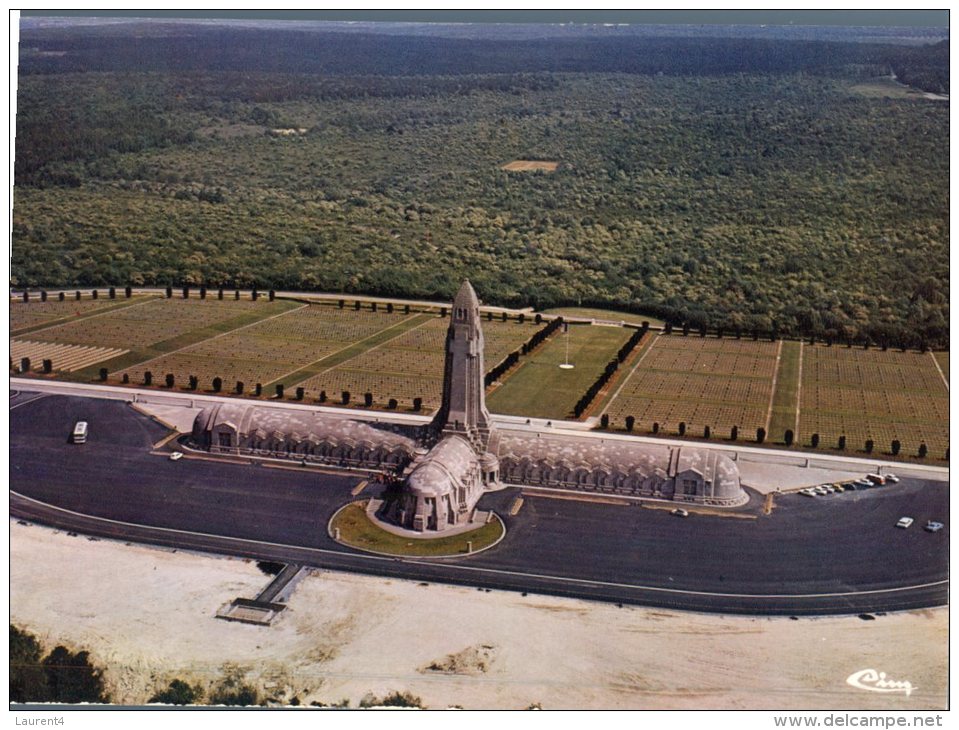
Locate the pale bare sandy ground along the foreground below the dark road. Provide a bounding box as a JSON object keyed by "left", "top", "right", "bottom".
{"left": 10, "top": 522, "right": 948, "bottom": 710}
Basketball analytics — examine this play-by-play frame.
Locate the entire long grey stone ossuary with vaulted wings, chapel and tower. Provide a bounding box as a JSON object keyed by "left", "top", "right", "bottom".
{"left": 192, "top": 281, "right": 748, "bottom": 533}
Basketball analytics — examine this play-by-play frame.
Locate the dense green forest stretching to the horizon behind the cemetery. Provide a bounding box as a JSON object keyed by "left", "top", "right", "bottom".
{"left": 12, "top": 26, "right": 949, "bottom": 345}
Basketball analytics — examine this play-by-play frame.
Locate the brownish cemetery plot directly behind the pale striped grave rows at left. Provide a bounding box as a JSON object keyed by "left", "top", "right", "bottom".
{"left": 31, "top": 299, "right": 263, "bottom": 350}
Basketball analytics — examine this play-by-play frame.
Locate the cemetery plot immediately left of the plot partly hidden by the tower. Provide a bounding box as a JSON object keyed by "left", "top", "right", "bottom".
{"left": 120, "top": 304, "right": 405, "bottom": 391}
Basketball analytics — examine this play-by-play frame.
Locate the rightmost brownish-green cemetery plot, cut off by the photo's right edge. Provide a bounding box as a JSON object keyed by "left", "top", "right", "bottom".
{"left": 799, "top": 345, "right": 949, "bottom": 458}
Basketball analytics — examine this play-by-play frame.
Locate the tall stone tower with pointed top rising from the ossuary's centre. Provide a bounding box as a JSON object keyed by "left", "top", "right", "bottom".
{"left": 432, "top": 280, "right": 490, "bottom": 454}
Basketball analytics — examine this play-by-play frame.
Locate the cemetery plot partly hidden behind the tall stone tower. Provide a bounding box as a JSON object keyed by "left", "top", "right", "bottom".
{"left": 299, "top": 317, "right": 545, "bottom": 411}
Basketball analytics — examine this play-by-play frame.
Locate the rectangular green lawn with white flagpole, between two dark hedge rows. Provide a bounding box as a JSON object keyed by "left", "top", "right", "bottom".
{"left": 486, "top": 325, "right": 633, "bottom": 418}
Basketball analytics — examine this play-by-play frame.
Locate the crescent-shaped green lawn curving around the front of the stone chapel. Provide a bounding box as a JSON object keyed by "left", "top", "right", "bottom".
{"left": 330, "top": 501, "right": 505, "bottom": 557}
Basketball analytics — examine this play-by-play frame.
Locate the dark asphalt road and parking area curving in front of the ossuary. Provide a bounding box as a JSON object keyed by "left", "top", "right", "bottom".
{"left": 10, "top": 393, "right": 949, "bottom": 614}
